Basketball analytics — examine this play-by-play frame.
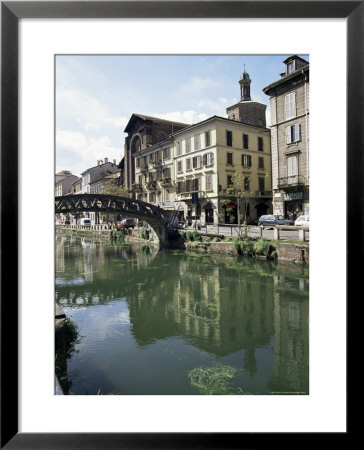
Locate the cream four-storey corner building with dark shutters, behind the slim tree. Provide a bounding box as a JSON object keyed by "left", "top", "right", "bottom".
{"left": 173, "top": 116, "right": 272, "bottom": 224}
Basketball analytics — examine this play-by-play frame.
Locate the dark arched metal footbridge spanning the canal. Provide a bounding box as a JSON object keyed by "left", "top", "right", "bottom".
{"left": 55, "top": 194, "right": 169, "bottom": 244}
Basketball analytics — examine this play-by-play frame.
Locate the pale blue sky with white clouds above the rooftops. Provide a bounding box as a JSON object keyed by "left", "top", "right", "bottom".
{"left": 55, "top": 55, "right": 309, "bottom": 176}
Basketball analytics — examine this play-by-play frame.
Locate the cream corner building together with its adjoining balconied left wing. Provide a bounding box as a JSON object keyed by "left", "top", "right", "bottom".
{"left": 132, "top": 116, "right": 272, "bottom": 224}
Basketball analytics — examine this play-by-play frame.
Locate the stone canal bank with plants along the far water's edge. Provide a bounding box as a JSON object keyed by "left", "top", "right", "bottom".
{"left": 56, "top": 226, "right": 310, "bottom": 264}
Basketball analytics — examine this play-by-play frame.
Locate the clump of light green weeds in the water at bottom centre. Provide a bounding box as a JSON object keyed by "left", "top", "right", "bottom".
{"left": 188, "top": 364, "right": 243, "bottom": 395}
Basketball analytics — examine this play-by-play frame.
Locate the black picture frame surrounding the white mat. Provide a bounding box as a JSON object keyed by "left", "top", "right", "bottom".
{"left": 1, "top": 0, "right": 358, "bottom": 449}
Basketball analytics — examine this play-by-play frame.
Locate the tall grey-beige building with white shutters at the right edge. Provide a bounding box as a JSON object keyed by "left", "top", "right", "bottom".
{"left": 263, "top": 55, "right": 309, "bottom": 219}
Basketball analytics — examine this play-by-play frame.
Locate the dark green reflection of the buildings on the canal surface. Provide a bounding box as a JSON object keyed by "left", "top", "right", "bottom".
{"left": 56, "top": 236, "right": 308, "bottom": 393}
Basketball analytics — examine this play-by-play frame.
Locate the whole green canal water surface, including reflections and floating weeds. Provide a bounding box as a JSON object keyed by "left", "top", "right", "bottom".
{"left": 56, "top": 235, "right": 309, "bottom": 395}
